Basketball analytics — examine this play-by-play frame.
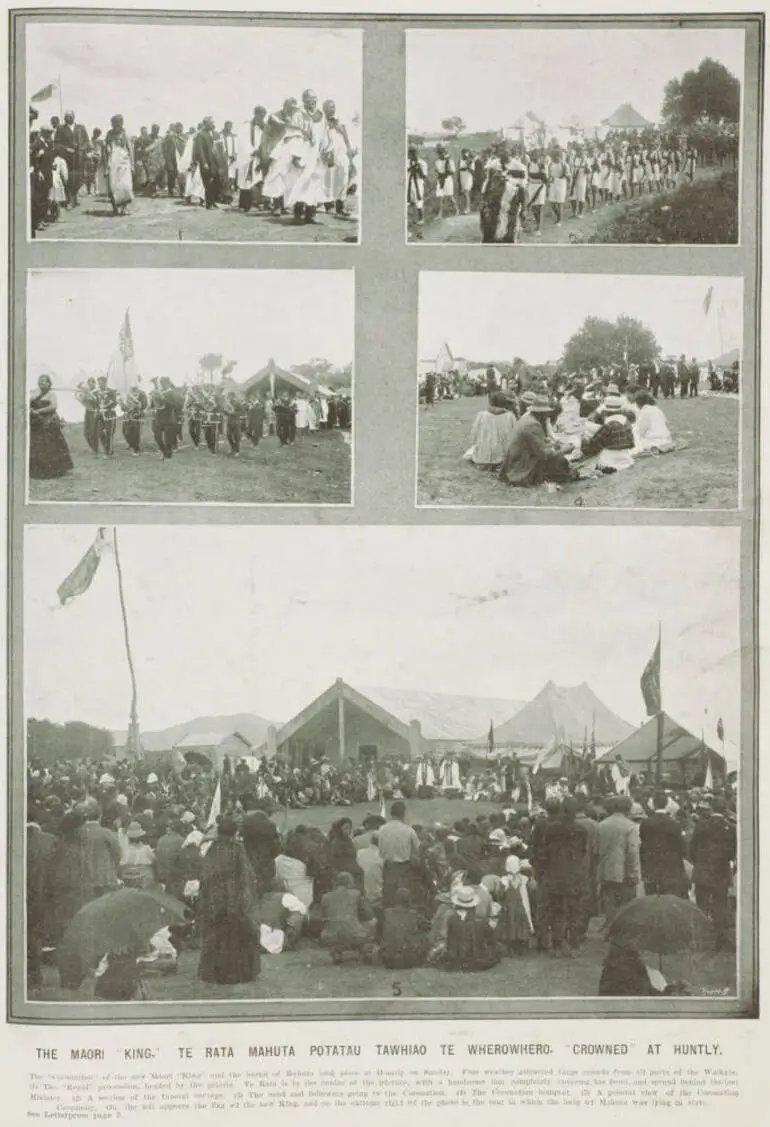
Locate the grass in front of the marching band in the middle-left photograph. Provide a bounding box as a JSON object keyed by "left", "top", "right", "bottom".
{"left": 29, "top": 424, "right": 351, "bottom": 505}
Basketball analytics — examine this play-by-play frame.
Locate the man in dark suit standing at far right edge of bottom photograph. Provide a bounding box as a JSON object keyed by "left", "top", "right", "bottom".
{"left": 690, "top": 798, "right": 737, "bottom": 950}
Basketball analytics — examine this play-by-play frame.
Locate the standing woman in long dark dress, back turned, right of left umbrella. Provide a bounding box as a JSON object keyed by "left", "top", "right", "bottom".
{"left": 198, "top": 816, "right": 260, "bottom": 985}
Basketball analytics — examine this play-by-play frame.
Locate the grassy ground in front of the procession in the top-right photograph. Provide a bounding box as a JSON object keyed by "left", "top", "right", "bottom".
{"left": 408, "top": 168, "right": 738, "bottom": 246}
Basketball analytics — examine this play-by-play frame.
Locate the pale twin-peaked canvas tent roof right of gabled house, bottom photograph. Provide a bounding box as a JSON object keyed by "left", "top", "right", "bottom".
{"left": 495, "top": 681, "right": 634, "bottom": 747}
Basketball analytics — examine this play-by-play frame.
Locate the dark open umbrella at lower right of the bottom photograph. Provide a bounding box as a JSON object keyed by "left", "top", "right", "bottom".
{"left": 607, "top": 896, "right": 713, "bottom": 957}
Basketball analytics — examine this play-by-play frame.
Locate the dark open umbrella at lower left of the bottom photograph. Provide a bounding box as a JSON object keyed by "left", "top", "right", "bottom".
{"left": 56, "top": 888, "right": 186, "bottom": 990}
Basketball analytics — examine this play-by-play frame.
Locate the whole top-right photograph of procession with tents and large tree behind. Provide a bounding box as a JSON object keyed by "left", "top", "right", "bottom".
{"left": 406, "top": 28, "right": 744, "bottom": 246}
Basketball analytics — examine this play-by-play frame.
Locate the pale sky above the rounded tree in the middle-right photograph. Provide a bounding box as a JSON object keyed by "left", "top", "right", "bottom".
{"left": 419, "top": 273, "right": 743, "bottom": 364}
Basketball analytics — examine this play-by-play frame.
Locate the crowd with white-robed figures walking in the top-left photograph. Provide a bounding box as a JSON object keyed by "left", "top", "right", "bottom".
{"left": 29, "top": 90, "right": 357, "bottom": 236}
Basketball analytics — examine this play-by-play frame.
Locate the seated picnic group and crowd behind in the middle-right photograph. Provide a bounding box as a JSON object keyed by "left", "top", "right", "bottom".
{"left": 419, "top": 355, "right": 740, "bottom": 487}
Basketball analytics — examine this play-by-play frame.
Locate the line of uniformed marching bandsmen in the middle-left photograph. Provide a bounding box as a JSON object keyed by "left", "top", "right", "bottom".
{"left": 76, "top": 376, "right": 352, "bottom": 459}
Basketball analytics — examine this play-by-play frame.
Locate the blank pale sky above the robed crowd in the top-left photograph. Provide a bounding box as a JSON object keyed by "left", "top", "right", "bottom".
{"left": 27, "top": 23, "right": 362, "bottom": 133}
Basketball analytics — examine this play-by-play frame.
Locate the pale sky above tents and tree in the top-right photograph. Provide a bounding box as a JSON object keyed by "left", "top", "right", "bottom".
{"left": 407, "top": 28, "right": 744, "bottom": 132}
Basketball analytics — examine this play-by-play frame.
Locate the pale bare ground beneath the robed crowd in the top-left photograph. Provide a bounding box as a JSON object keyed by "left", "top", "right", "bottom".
{"left": 37, "top": 194, "right": 359, "bottom": 242}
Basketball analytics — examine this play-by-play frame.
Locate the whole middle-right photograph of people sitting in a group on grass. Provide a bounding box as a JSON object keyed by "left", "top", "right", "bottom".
{"left": 416, "top": 272, "right": 743, "bottom": 511}
